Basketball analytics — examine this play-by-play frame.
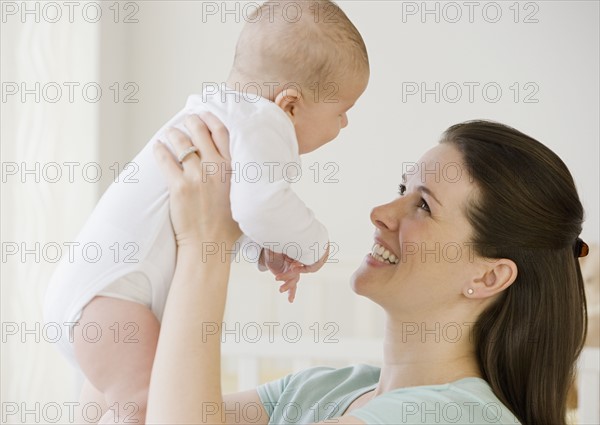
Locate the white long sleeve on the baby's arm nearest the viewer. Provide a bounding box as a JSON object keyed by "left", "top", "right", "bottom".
{"left": 231, "top": 116, "right": 329, "bottom": 271}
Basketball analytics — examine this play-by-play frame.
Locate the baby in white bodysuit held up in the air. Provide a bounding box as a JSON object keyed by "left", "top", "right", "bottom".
{"left": 45, "top": 0, "right": 369, "bottom": 423}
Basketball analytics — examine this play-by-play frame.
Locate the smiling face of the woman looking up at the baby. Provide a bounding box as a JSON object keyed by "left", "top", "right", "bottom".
{"left": 352, "top": 144, "right": 478, "bottom": 313}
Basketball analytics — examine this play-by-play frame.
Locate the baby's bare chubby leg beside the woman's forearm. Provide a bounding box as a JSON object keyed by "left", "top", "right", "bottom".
{"left": 74, "top": 297, "right": 160, "bottom": 424}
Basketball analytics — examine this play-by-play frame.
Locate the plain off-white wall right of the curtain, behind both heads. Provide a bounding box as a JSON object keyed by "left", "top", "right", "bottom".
{"left": 107, "top": 1, "right": 599, "bottom": 258}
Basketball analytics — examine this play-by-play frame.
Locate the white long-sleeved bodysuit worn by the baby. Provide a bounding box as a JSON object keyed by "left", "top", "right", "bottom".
{"left": 44, "top": 90, "right": 328, "bottom": 361}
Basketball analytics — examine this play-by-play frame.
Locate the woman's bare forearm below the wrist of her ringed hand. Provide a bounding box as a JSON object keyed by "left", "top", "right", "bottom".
{"left": 146, "top": 244, "right": 230, "bottom": 424}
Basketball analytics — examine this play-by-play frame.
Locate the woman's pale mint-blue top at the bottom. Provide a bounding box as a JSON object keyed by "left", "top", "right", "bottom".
{"left": 258, "top": 365, "right": 519, "bottom": 425}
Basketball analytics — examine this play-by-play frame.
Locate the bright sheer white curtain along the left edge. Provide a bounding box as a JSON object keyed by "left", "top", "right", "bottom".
{"left": 0, "top": 6, "right": 100, "bottom": 423}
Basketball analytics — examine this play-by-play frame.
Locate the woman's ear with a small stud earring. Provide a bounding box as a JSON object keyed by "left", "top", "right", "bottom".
{"left": 463, "top": 258, "right": 518, "bottom": 298}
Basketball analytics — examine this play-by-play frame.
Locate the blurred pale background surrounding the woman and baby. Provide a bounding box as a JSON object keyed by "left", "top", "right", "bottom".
{"left": 0, "top": 0, "right": 600, "bottom": 423}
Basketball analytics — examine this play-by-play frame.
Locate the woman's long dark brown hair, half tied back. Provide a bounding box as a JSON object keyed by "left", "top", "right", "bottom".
{"left": 441, "top": 121, "right": 587, "bottom": 425}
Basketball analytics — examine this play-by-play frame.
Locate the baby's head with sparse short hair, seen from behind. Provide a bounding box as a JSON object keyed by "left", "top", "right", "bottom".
{"left": 229, "top": 0, "right": 369, "bottom": 154}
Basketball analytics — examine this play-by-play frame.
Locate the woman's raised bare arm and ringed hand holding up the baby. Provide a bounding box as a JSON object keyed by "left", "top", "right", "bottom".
{"left": 146, "top": 115, "right": 258, "bottom": 424}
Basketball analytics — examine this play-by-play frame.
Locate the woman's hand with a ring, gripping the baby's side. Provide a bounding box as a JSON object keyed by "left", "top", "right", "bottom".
{"left": 154, "top": 112, "right": 242, "bottom": 249}
